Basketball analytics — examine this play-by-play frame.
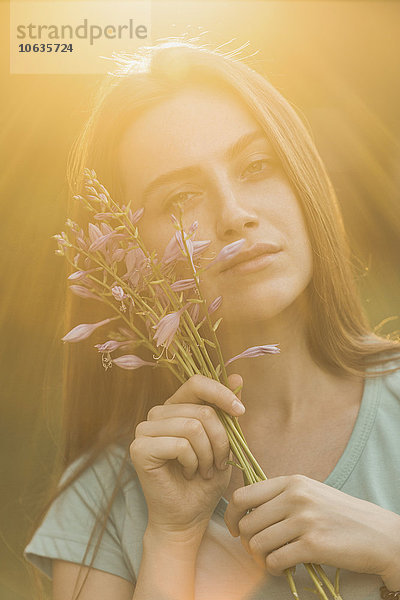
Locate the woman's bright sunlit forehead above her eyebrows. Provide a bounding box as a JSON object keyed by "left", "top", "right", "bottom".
{"left": 119, "top": 87, "right": 268, "bottom": 185}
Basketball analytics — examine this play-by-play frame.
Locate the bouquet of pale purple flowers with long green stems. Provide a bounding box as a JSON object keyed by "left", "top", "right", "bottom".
{"left": 53, "top": 169, "right": 341, "bottom": 600}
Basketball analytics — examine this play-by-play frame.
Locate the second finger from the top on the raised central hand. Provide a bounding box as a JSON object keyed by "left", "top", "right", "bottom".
{"left": 147, "top": 404, "right": 229, "bottom": 470}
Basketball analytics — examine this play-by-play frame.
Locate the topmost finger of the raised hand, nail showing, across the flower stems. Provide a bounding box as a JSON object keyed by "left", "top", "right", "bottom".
{"left": 165, "top": 375, "right": 245, "bottom": 417}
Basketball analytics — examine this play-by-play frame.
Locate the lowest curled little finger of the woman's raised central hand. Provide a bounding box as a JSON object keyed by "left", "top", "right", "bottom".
{"left": 130, "top": 436, "right": 198, "bottom": 479}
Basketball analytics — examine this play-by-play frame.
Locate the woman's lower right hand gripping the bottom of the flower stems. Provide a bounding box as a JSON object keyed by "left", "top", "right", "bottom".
{"left": 225, "top": 475, "right": 400, "bottom": 578}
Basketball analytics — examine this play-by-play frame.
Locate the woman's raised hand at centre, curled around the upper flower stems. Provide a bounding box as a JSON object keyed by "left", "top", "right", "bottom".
{"left": 130, "top": 375, "right": 244, "bottom": 540}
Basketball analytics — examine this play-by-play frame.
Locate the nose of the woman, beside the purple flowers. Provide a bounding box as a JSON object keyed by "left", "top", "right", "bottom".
{"left": 215, "top": 176, "right": 259, "bottom": 241}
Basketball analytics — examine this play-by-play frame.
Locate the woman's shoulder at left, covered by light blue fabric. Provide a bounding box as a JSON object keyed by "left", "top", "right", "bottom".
{"left": 24, "top": 445, "right": 138, "bottom": 581}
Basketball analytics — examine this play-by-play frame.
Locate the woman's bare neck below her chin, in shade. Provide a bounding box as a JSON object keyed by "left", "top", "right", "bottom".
{"left": 221, "top": 304, "right": 363, "bottom": 427}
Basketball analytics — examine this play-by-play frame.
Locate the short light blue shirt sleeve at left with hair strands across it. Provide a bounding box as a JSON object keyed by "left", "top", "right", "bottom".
{"left": 24, "top": 448, "right": 134, "bottom": 583}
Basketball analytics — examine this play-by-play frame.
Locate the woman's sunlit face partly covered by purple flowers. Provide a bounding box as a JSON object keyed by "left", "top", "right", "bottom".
{"left": 119, "top": 87, "right": 312, "bottom": 324}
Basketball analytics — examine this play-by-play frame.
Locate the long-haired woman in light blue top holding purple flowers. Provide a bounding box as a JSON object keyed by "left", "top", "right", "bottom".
{"left": 25, "top": 42, "right": 400, "bottom": 600}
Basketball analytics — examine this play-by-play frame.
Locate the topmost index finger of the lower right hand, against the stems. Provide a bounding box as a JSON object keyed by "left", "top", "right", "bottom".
{"left": 224, "top": 476, "right": 288, "bottom": 537}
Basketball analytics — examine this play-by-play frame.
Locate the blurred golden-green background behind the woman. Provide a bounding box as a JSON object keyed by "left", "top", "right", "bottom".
{"left": 0, "top": 0, "right": 400, "bottom": 600}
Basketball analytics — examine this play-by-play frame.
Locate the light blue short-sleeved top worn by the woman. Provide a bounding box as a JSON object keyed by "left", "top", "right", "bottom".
{"left": 24, "top": 364, "right": 400, "bottom": 600}
